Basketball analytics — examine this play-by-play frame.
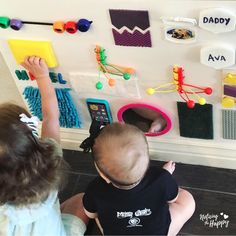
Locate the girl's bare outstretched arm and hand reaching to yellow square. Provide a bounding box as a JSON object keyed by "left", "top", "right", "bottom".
{"left": 21, "top": 56, "right": 60, "bottom": 142}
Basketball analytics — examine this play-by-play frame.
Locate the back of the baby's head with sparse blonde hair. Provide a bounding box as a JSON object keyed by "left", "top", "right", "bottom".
{"left": 93, "top": 123, "right": 149, "bottom": 185}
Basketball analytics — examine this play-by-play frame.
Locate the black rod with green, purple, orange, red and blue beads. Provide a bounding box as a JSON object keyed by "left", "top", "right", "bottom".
{"left": 0, "top": 16, "right": 92, "bottom": 34}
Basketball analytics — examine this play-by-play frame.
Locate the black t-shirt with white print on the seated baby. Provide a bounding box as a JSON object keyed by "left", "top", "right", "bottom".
{"left": 83, "top": 167, "right": 178, "bottom": 235}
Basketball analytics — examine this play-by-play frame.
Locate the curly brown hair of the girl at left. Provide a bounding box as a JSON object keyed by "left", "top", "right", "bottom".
{"left": 0, "top": 103, "right": 67, "bottom": 205}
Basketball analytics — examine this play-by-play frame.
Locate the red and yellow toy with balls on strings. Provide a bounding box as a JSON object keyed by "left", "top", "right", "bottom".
{"left": 146, "top": 65, "right": 212, "bottom": 108}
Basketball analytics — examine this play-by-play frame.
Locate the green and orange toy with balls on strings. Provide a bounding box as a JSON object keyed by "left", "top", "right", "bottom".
{"left": 94, "top": 45, "right": 135, "bottom": 90}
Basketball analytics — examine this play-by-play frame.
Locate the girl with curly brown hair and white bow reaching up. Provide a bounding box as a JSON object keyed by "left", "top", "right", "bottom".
{"left": 0, "top": 56, "right": 88, "bottom": 236}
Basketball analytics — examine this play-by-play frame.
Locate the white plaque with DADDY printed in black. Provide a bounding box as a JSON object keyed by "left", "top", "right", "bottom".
{"left": 199, "top": 8, "right": 236, "bottom": 33}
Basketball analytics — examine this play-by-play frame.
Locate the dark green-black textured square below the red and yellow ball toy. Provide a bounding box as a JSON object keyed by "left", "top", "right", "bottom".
{"left": 177, "top": 102, "right": 213, "bottom": 139}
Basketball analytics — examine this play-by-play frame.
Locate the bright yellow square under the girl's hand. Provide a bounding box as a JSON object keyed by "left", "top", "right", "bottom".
{"left": 8, "top": 39, "right": 58, "bottom": 68}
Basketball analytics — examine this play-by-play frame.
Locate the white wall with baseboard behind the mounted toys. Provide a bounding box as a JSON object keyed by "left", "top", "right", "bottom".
{"left": 0, "top": 0, "right": 236, "bottom": 169}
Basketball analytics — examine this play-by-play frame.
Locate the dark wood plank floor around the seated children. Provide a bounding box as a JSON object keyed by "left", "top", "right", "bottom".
{"left": 59, "top": 150, "right": 236, "bottom": 235}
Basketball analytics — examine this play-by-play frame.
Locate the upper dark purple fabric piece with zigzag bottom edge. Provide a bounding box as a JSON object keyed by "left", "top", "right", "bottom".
{"left": 109, "top": 9, "right": 150, "bottom": 30}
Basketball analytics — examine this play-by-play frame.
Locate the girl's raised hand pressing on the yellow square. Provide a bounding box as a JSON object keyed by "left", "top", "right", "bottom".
{"left": 21, "top": 56, "right": 49, "bottom": 79}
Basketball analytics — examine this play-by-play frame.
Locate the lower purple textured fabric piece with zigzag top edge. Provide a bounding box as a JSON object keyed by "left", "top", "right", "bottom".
{"left": 112, "top": 29, "right": 152, "bottom": 47}
